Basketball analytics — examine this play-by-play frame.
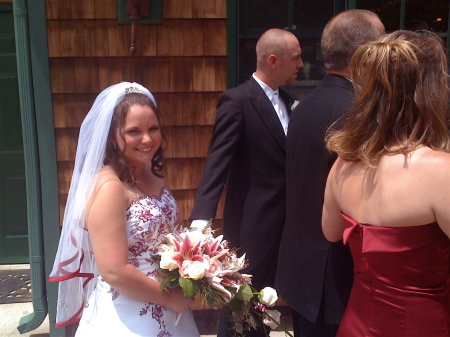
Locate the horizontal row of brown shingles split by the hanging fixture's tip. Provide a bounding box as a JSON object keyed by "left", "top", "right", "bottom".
{"left": 47, "top": 19, "right": 227, "bottom": 57}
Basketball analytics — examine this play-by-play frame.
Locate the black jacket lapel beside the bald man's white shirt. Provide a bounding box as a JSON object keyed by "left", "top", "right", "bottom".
{"left": 247, "top": 78, "right": 286, "bottom": 151}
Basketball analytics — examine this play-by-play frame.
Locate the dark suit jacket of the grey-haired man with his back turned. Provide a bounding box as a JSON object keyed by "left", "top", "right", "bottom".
{"left": 275, "top": 74, "right": 354, "bottom": 324}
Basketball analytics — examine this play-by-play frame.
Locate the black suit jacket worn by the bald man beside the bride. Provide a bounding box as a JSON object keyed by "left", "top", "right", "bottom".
{"left": 190, "top": 78, "right": 293, "bottom": 290}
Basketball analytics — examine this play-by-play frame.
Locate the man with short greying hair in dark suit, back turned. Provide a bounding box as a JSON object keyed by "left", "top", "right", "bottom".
{"left": 276, "top": 10, "right": 384, "bottom": 337}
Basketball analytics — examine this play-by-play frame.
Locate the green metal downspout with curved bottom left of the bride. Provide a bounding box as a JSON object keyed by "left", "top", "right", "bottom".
{"left": 13, "top": 0, "right": 47, "bottom": 333}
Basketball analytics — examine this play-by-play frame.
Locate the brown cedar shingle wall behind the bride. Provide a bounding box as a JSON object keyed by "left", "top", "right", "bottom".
{"left": 46, "top": 0, "right": 226, "bottom": 226}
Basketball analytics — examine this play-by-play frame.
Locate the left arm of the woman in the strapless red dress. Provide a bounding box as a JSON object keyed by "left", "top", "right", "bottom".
{"left": 322, "top": 158, "right": 345, "bottom": 242}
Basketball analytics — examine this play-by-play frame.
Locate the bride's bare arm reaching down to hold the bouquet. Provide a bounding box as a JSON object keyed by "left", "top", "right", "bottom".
{"left": 87, "top": 179, "right": 191, "bottom": 312}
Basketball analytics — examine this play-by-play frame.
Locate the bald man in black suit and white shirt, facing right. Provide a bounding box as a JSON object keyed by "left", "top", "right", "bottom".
{"left": 190, "top": 29, "right": 303, "bottom": 337}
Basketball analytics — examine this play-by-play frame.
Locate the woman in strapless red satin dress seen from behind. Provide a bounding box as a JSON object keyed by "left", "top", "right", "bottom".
{"left": 322, "top": 31, "right": 450, "bottom": 337}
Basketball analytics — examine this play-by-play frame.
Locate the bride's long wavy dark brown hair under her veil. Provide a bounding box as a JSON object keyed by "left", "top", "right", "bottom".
{"left": 104, "top": 93, "right": 166, "bottom": 185}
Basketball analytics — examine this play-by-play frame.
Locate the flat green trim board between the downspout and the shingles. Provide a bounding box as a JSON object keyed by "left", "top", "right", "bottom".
{"left": 28, "top": 0, "right": 66, "bottom": 337}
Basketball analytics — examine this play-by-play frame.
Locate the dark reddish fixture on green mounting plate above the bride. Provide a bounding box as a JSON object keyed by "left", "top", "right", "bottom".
{"left": 117, "top": 0, "right": 162, "bottom": 55}
